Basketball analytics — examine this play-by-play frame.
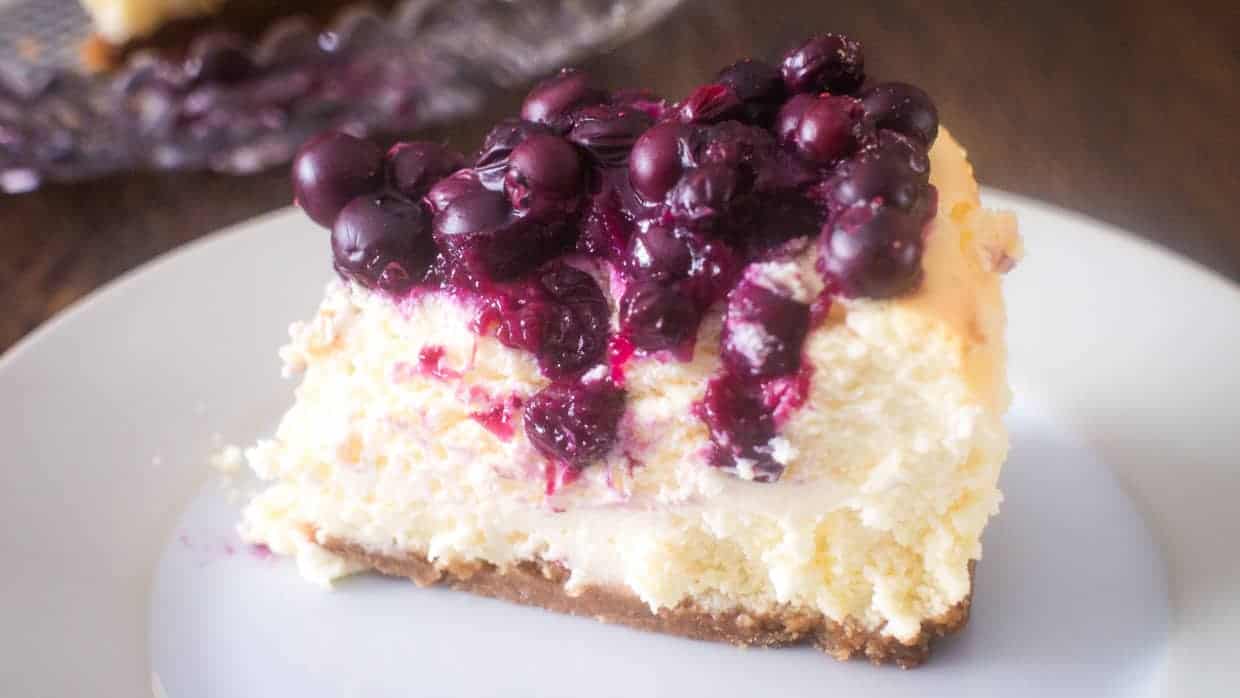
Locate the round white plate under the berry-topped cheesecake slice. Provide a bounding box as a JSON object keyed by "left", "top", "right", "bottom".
{"left": 0, "top": 192, "right": 1240, "bottom": 698}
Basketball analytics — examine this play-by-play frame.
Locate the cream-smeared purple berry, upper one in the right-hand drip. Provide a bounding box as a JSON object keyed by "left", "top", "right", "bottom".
{"left": 723, "top": 279, "right": 810, "bottom": 378}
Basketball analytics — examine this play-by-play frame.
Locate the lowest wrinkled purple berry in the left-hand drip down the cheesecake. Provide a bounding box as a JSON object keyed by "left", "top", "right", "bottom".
{"left": 525, "top": 382, "right": 625, "bottom": 469}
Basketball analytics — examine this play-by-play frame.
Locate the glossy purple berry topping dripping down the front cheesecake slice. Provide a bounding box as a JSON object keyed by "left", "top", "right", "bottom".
{"left": 287, "top": 33, "right": 939, "bottom": 481}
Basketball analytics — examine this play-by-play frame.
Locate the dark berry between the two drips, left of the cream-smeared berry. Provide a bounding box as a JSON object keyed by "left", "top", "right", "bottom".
{"left": 620, "top": 280, "right": 702, "bottom": 351}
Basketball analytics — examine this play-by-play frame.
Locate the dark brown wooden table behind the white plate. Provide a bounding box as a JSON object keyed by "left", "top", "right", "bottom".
{"left": 0, "top": 0, "right": 1240, "bottom": 351}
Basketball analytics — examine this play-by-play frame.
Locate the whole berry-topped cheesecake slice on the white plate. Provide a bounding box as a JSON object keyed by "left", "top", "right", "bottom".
{"left": 233, "top": 35, "right": 1021, "bottom": 666}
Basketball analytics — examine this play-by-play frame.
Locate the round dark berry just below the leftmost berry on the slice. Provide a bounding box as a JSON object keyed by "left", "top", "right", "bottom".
{"left": 331, "top": 195, "right": 435, "bottom": 294}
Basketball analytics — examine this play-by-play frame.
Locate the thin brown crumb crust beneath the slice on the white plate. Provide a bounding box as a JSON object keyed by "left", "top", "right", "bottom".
{"left": 324, "top": 539, "right": 976, "bottom": 668}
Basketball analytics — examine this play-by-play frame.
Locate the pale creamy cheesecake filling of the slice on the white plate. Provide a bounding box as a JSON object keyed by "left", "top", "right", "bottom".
{"left": 242, "top": 133, "right": 1019, "bottom": 640}
